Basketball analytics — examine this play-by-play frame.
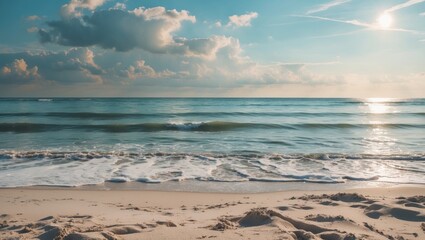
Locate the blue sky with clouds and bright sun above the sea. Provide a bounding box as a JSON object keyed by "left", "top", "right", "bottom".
{"left": 0, "top": 0, "right": 425, "bottom": 98}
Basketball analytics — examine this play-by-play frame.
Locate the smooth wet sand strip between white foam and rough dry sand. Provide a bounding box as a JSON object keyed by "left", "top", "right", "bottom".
{"left": 0, "top": 180, "right": 425, "bottom": 194}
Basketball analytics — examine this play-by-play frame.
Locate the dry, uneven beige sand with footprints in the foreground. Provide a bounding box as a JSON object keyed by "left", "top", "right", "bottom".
{"left": 0, "top": 185, "right": 425, "bottom": 240}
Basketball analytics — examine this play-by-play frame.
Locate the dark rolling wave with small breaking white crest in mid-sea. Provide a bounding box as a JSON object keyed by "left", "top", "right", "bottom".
{"left": 0, "top": 121, "right": 425, "bottom": 133}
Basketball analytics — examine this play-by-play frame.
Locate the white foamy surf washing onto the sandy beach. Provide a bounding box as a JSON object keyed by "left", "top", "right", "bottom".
{"left": 0, "top": 150, "right": 425, "bottom": 187}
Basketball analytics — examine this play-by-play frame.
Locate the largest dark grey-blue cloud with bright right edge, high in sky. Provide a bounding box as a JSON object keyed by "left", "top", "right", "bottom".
{"left": 39, "top": 7, "right": 238, "bottom": 59}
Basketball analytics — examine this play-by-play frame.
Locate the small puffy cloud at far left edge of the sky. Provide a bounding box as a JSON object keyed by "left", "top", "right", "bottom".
{"left": 0, "top": 59, "right": 40, "bottom": 83}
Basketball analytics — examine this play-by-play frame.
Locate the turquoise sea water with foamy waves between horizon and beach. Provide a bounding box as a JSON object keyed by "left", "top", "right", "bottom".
{"left": 0, "top": 98, "right": 425, "bottom": 187}
